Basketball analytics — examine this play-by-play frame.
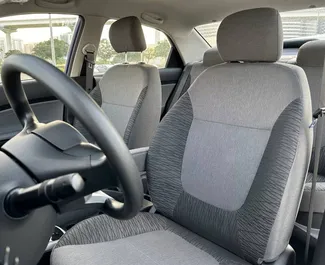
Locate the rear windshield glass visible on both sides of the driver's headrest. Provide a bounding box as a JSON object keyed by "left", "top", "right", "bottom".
{"left": 196, "top": 7, "right": 325, "bottom": 46}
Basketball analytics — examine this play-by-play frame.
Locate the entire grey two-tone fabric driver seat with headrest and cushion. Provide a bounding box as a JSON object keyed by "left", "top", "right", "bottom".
{"left": 51, "top": 8, "right": 312, "bottom": 265}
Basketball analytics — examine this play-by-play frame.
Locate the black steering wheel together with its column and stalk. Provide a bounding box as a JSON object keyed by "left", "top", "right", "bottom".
{"left": 0, "top": 55, "right": 143, "bottom": 265}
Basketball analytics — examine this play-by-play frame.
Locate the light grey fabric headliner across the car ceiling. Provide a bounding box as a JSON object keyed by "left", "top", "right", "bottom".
{"left": 0, "top": 0, "right": 325, "bottom": 30}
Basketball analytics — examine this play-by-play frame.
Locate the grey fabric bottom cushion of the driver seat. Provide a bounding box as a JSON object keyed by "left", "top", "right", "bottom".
{"left": 51, "top": 213, "right": 249, "bottom": 265}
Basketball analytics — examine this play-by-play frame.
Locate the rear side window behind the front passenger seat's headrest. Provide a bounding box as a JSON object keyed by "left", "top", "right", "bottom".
{"left": 95, "top": 20, "right": 171, "bottom": 74}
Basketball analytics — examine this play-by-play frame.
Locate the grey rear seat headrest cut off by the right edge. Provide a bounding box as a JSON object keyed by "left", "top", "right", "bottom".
{"left": 297, "top": 40, "right": 325, "bottom": 67}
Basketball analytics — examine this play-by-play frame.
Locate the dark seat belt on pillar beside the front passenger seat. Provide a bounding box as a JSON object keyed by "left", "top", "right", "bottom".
{"left": 82, "top": 44, "right": 96, "bottom": 93}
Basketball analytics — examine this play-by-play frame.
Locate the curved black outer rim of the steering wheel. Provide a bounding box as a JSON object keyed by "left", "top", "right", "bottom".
{"left": 1, "top": 54, "right": 143, "bottom": 219}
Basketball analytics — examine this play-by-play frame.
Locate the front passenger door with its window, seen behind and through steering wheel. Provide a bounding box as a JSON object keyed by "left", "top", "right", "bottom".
{"left": 0, "top": 12, "right": 84, "bottom": 143}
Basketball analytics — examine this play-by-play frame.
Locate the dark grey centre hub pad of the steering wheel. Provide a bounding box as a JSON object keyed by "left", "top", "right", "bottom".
{"left": 2, "top": 121, "right": 106, "bottom": 182}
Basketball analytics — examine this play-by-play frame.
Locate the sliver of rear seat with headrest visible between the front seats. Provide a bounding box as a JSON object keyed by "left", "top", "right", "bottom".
{"left": 164, "top": 48, "right": 223, "bottom": 114}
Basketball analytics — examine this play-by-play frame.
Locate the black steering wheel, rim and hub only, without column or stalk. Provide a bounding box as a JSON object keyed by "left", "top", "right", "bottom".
{"left": 1, "top": 54, "right": 143, "bottom": 219}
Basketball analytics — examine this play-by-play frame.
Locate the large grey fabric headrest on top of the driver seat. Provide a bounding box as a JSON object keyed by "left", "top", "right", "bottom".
{"left": 217, "top": 8, "right": 283, "bottom": 62}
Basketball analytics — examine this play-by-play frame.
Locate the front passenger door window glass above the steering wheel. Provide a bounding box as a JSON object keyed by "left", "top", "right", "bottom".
{"left": 0, "top": 14, "right": 79, "bottom": 81}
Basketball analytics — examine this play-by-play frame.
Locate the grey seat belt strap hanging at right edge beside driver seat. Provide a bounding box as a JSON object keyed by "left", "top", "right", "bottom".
{"left": 305, "top": 55, "right": 325, "bottom": 265}
